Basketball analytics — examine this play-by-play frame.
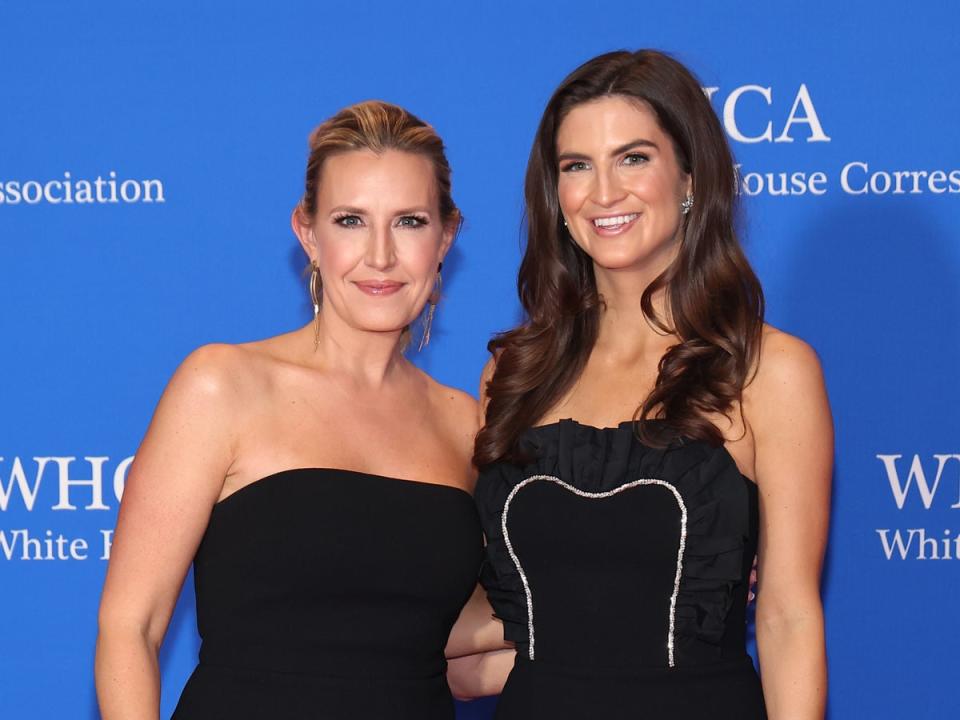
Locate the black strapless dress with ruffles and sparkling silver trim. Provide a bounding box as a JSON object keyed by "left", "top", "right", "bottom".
{"left": 476, "top": 420, "right": 766, "bottom": 720}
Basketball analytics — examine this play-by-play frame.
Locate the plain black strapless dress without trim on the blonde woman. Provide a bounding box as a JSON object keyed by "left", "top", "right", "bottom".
{"left": 173, "top": 469, "right": 483, "bottom": 720}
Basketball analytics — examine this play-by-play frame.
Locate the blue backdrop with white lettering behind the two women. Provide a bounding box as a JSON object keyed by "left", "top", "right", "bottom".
{"left": 0, "top": 0, "right": 960, "bottom": 720}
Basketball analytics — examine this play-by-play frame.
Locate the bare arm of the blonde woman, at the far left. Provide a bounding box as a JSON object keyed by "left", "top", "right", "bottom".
{"left": 96, "top": 346, "right": 238, "bottom": 720}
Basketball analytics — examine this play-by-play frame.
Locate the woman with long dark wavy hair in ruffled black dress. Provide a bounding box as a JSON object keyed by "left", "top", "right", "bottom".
{"left": 474, "top": 51, "right": 833, "bottom": 720}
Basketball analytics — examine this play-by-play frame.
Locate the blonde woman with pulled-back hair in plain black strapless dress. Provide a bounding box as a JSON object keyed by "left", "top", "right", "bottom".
{"left": 96, "top": 102, "right": 502, "bottom": 720}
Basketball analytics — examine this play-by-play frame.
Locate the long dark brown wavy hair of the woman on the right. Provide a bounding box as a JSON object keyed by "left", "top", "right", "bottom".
{"left": 474, "top": 50, "right": 764, "bottom": 466}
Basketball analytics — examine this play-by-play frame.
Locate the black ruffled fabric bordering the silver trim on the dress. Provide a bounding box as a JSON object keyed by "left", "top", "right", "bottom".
{"left": 475, "top": 420, "right": 757, "bottom": 665}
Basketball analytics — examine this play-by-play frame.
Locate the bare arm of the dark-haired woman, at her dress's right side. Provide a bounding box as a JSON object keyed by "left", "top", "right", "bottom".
{"left": 745, "top": 331, "right": 833, "bottom": 720}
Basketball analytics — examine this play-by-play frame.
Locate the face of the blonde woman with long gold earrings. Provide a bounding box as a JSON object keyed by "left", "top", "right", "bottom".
{"left": 294, "top": 150, "right": 454, "bottom": 333}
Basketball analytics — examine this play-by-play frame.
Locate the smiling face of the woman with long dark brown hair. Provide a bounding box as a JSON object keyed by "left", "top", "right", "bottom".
{"left": 557, "top": 96, "right": 692, "bottom": 280}
